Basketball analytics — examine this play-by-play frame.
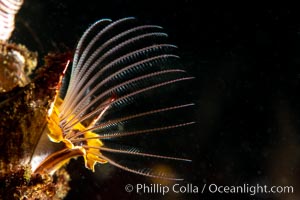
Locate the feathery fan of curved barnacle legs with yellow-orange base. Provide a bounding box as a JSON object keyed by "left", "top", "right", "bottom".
{"left": 36, "top": 18, "right": 193, "bottom": 180}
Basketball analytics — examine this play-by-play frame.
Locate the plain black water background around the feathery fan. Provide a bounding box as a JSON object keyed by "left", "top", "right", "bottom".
{"left": 12, "top": 0, "right": 300, "bottom": 200}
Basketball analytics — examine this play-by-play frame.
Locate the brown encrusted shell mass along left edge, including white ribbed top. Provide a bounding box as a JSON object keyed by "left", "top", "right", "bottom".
{"left": 0, "top": 0, "right": 70, "bottom": 200}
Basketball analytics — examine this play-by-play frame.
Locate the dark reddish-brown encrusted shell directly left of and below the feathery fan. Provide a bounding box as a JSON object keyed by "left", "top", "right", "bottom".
{"left": 0, "top": 48, "right": 69, "bottom": 199}
